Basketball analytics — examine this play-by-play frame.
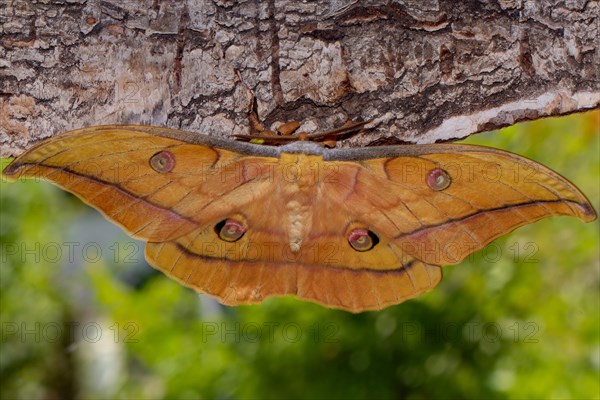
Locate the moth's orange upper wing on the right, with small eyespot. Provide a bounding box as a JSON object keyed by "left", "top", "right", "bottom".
{"left": 355, "top": 145, "right": 596, "bottom": 265}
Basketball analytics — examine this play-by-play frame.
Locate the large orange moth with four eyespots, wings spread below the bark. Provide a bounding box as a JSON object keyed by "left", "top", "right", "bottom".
{"left": 3, "top": 125, "right": 596, "bottom": 312}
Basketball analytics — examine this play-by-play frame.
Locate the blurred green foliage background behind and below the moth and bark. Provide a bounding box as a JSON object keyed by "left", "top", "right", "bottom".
{"left": 0, "top": 111, "right": 600, "bottom": 399}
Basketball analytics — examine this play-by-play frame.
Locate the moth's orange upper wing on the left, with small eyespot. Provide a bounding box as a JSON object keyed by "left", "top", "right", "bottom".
{"left": 3, "top": 125, "right": 276, "bottom": 241}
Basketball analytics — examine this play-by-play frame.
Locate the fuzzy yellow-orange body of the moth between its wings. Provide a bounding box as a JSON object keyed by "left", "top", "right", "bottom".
{"left": 280, "top": 153, "right": 323, "bottom": 253}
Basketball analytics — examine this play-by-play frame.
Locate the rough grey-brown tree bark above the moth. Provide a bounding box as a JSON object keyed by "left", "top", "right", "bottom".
{"left": 0, "top": 0, "right": 600, "bottom": 156}
